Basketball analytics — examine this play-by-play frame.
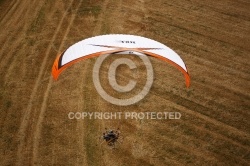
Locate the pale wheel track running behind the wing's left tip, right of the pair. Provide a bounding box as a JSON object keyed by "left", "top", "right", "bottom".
{"left": 32, "top": 0, "right": 82, "bottom": 164}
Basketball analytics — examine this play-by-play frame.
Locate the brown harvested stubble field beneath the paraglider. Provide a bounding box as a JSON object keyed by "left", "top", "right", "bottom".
{"left": 0, "top": 0, "right": 250, "bottom": 166}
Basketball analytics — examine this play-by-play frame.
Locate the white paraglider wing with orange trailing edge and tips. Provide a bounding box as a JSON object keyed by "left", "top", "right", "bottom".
{"left": 52, "top": 34, "right": 190, "bottom": 87}
